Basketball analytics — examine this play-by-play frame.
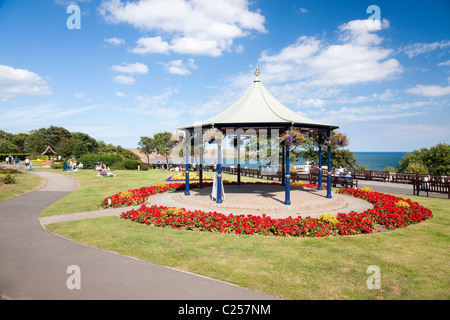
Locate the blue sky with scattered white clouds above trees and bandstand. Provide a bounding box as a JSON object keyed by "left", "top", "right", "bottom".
{"left": 0, "top": 0, "right": 450, "bottom": 151}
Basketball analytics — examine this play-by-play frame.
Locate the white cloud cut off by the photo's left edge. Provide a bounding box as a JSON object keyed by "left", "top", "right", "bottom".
{"left": 0, "top": 65, "right": 52, "bottom": 101}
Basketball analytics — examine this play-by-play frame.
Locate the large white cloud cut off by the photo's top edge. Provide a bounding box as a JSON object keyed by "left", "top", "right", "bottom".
{"left": 99, "top": 0, "right": 267, "bottom": 56}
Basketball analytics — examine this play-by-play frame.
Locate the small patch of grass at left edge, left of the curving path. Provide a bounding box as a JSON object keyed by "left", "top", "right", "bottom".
{"left": 0, "top": 173, "right": 47, "bottom": 201}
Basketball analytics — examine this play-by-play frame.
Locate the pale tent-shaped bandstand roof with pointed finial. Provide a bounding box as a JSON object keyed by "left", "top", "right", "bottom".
{"left": 178, "top": 69, "right": 339, "bottom": 132}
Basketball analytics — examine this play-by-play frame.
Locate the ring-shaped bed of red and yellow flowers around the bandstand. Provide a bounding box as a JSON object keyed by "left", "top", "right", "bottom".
{"left": 101, "top": 182, "right": 432, "bottom": 237}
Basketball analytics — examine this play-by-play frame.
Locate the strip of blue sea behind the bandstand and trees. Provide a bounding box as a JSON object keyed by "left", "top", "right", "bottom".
{"left": 216, "top": 152, "right": 408, "bottom": 171}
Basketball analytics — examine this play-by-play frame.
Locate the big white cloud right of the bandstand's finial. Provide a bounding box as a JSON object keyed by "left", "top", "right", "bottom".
{"left": 255, "top": 20, "right": 402, "bottom": 89}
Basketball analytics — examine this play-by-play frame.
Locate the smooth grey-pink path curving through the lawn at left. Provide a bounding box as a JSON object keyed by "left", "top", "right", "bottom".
{"left": 0, "top": 171, "right": 277, "bottom": 300}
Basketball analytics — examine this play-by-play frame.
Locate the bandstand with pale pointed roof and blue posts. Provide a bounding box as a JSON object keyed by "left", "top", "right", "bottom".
{"left": 177, "top": 68, "right": 339, "bottom": 205}
